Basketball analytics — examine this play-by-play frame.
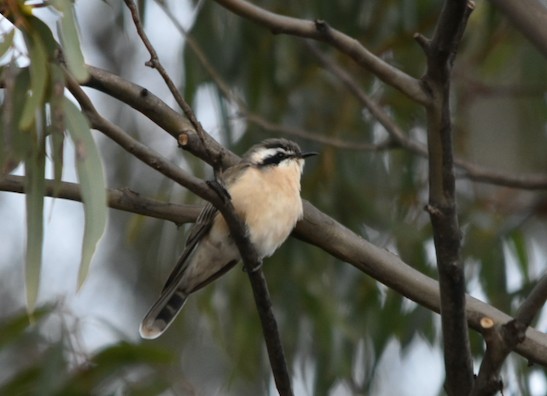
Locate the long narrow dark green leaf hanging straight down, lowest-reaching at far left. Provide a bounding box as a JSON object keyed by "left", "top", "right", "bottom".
{"left": 25, "top": 112, "right": 46, "bottom": 312}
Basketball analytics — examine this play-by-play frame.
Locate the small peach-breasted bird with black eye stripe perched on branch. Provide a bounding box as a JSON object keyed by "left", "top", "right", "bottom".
{"left": 139, "top": 138, "right": 318, "bottom": 339}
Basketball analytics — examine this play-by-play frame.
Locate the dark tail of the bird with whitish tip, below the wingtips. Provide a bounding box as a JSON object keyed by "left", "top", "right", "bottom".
{"left": 139, "top": 289, "right": 188, "bottom": 340}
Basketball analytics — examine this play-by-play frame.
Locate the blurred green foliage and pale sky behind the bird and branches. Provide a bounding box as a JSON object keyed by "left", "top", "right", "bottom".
{"left": 0, "top": 0, "right": 547, "bottom": 396}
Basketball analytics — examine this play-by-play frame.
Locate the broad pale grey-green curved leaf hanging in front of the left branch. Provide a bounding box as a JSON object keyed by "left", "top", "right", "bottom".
{"left": 64, "top": 98, "right": 108, "bottom": 287}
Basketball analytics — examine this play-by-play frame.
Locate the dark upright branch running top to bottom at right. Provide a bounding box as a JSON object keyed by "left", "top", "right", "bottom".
{"left": 417, "top": 0, "right": 474, "bottom": 396}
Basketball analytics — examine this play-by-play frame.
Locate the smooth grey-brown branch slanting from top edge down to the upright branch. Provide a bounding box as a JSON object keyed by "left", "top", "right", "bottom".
{"left": 210, "top": 0, "right": 429, "bottom": 104}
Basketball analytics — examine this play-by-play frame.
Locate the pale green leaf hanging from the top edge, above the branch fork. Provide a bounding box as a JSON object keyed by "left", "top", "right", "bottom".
{"left": 55, "top": 0, "right": 89, "bottom": 82}
